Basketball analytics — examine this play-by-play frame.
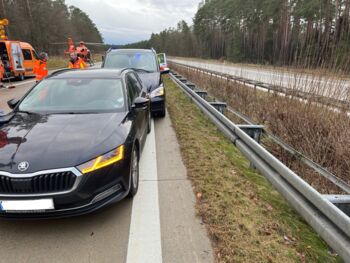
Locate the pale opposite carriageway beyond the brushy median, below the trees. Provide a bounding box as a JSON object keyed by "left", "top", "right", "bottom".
{"left": 168, "top": 58, "right": 350, "bottom": 100}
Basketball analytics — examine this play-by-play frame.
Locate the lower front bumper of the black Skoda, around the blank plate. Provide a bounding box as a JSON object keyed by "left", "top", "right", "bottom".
{"left": 0, "top": 158, "right": 130, "bottom": 219}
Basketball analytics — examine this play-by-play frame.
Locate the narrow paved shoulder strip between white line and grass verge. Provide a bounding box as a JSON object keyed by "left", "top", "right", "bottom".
{"left": 155, "top": 116, "right": 214, "bottom": 263}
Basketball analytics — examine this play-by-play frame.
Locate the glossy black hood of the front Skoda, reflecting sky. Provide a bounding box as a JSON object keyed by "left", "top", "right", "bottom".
{"left": 0, "top": 113, "right": 129, "bottom": 174}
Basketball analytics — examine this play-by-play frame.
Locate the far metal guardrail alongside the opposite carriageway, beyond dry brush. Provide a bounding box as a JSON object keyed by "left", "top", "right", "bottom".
{"left": 169, "top": 60, "right": 350, "bottom": 111}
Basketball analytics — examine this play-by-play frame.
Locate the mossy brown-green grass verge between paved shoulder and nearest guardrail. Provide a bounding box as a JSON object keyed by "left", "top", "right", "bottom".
{"left": 165, "top": 77, "right": 339, "bottom": 263}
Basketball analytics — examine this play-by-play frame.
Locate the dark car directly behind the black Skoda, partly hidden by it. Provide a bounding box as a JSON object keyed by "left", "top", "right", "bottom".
{"left": 102, "top": 49, "right": 169, "bottom": 117}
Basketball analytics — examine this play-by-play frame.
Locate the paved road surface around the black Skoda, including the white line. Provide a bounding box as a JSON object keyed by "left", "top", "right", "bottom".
{"left": 0, "top": 75, "right": 214, "bottom": 263}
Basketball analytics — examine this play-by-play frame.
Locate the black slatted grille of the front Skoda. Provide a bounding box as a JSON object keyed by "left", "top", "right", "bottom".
{"left": 0, "top": 171, "right": 76, "bottom": 194}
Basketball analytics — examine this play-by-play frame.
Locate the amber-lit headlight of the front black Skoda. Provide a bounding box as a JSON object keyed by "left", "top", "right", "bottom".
{"left": 77, "top": 145, "right": 125, "bottom": 174}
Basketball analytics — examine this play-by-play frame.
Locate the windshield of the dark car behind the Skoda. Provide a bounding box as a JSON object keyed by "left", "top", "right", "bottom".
{"left": 104, "top": 51, "right": 158, "bottom": 72}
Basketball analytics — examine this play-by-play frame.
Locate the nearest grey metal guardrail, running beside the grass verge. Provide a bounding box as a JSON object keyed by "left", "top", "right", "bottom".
{"left": 170, "top": 71, "right": 350, "bottom": 263}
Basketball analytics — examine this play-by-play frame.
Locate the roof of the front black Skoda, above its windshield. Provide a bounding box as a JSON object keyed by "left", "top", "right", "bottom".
{"left": 48, "top": 68, "right": 128, "bottom": 79}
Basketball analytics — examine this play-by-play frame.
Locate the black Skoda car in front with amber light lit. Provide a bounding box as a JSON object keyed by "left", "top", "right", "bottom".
{"left": 0, "top": 69, "right": 151, "bottom": 218}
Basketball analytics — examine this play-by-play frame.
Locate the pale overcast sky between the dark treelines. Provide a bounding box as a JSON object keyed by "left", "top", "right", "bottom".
{"left": 66, "top": 0, "right": 200, "bottom": 44}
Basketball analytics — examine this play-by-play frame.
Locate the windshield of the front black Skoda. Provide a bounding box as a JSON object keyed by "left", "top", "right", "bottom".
{"left": 18, "top": 79, "right": 126, "bottom": 113}
